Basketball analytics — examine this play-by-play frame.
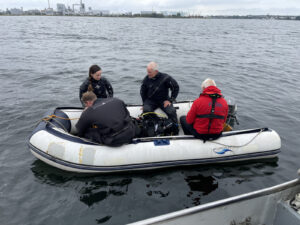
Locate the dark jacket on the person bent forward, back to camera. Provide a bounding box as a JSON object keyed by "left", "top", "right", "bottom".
{"left": 76, "top": 98, "right": 135, "bottom": 146}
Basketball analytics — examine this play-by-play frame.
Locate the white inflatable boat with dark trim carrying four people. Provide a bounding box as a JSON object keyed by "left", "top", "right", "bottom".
{"left": 28, "top": 101, "right": 281, "bottom": 173}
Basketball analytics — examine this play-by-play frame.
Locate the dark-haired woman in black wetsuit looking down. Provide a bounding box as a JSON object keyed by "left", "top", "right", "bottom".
{"left": 79, "top": 65, "right": 114, "bottom": 105}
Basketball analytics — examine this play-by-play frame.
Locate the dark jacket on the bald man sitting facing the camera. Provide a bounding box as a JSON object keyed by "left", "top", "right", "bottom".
{"left": 140, "top": 72, "right": 179, "bottom": 104}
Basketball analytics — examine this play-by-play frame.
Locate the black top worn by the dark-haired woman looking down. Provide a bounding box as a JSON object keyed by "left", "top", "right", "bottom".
{"left": 79, "top": 77, "right": 114, "bottom": 101}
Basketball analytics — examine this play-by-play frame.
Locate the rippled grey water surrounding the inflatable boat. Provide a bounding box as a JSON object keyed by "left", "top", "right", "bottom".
{"left": 0, "top": 16, "right": 300, "bottom": 225}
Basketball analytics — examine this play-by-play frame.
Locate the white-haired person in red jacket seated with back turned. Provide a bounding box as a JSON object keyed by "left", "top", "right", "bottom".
{"left": 180, "top": 78, "right": 228, "bottom": 141}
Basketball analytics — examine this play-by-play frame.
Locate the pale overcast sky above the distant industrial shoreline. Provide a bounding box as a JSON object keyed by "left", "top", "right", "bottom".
{"left": 0, "top": 0, "right": 300, "bottom": 15}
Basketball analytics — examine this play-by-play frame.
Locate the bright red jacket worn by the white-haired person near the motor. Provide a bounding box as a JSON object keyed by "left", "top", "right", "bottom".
{"left": 186, "top": 86, "right": 228, "bottom": 134}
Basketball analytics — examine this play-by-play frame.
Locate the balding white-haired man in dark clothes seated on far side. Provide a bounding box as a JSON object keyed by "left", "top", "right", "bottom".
{"left": 140, "top": 62, "right": 179, "bottom": 124}
